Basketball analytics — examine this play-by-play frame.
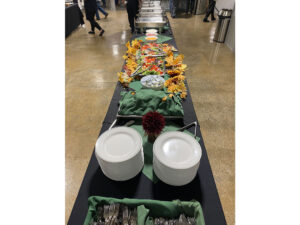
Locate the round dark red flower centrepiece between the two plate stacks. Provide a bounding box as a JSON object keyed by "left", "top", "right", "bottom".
{"left": 143, "top": 112, "right": 165, "bottom": 142}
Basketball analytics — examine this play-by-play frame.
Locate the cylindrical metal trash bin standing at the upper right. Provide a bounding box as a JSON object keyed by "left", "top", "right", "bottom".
{"left": 214, "top": 9, "right": 232, "bottom": 43}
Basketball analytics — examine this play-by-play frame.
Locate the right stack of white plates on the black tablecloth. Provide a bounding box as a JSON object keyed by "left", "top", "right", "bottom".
{"left": 153, "top": 131, "right": 202, "bottom": 186}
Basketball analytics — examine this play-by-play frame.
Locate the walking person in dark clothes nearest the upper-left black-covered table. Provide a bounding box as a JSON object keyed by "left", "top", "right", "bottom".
{"left": 84, "top": 0, "right": 104, "bottom": 36}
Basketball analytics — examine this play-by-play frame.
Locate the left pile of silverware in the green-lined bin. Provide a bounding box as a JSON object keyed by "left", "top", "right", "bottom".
{"left": 90, "top": 203, "right": 137, "bottom": 225}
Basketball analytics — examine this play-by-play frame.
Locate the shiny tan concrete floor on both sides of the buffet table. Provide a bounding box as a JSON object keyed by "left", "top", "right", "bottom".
{"left": 65, "top": 10, "right": 235, "bottom": 225}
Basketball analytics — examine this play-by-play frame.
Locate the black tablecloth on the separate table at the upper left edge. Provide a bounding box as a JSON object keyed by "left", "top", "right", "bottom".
{"left": 65, "top": 3, "right": 80, "bottom": 37}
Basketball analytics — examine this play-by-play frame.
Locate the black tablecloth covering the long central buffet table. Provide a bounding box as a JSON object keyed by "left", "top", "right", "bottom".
{"left": 68, "top": 21, "right": 226, "bottom": 225}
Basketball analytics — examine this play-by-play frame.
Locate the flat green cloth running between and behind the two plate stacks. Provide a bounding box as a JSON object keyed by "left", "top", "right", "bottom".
{"left": 131, "top": 122, "right": 200, "bottom": 183}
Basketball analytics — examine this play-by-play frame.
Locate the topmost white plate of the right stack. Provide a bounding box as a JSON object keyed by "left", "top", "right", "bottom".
{"left": 153, "top": 131, "right": 202, "bottom": 169}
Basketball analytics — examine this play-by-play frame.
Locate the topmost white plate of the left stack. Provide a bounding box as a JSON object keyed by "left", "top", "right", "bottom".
{"left": 95, "top": 127, "right": 143, "bottom": 162}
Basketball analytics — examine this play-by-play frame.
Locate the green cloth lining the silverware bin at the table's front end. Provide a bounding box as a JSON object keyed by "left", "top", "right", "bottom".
{"left": 84, "top": 196, "right": 205, "bottom": 225}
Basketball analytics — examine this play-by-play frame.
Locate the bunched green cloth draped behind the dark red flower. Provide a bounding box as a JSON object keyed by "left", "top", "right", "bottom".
{"left": 119, "top": 89, "right": 183, "bottom": 116}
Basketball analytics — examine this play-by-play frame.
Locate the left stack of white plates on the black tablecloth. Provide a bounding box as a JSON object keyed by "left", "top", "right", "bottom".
{"left": 95, "top": 127, "right": 144, "bottom": 181}
